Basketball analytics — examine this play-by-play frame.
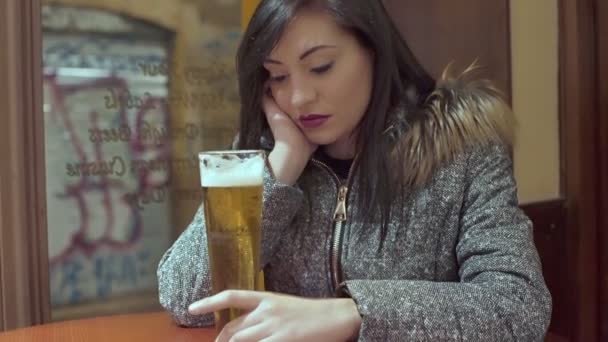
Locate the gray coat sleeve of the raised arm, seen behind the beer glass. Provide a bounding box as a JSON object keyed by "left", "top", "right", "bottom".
{"left": 157, "top": 156, "right": 303, "bottom": 327}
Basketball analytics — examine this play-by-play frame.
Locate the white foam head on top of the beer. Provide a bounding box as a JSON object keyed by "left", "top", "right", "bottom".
{"left": 201, "top": 154, "right": 264, "bottom": 188}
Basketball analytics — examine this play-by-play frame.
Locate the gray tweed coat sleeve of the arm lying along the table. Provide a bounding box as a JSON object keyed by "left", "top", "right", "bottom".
{"left": 338, "top": 146, "right": 552, "bottom": 341}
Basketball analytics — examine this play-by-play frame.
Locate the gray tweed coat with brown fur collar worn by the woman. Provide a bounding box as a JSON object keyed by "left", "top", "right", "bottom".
{"left": 158, "top": 71, "right": 551, "bottom": 341}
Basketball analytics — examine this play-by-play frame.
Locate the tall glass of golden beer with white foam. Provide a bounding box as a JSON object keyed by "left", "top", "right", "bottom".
{"left": 199, "top": 150, "right": 265, "bottom": 332}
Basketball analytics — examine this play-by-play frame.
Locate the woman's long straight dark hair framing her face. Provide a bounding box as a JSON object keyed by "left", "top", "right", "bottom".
{"left": 237, "top": 0, "right": 435, "bottom": 247}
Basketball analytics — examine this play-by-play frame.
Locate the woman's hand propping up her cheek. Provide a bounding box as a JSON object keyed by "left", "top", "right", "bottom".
{"left": 263, "top": 88, "right": 318, "bottom": 185}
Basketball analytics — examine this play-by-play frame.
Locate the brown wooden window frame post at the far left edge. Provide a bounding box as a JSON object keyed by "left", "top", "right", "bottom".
{"left": 0, "top": 0, "right": 50, "bottom": 331}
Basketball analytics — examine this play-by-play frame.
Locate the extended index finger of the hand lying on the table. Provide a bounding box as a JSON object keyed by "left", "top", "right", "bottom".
{"left": 188, "top": 290, "right": 267, "bottom": 315}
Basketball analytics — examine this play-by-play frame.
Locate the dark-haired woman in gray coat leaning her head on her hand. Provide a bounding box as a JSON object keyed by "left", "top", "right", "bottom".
{"left": 158, "top": 0, "right": 551, "bottom": 342}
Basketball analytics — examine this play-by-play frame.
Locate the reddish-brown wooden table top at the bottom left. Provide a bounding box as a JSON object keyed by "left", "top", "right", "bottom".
{"left": 0, "top": 312, "right": 216, "bottom": 342}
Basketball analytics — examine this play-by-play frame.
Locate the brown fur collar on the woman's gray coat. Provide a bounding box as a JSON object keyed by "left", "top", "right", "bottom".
{"left": 392, "top": 65, "right": 515, "bottom": 187}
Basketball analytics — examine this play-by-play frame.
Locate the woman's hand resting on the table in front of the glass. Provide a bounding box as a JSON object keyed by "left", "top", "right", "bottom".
{"left": 188, "top": 290, "right": 361, "bottom": 342}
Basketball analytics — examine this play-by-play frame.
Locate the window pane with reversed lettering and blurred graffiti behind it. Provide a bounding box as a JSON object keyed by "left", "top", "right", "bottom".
{"left": 42, "top": 0, "right": 241, "bottom": 320}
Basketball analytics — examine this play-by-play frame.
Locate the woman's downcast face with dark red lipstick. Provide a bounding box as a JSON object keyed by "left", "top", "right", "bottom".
{"left": 264, "top": 9, "right": 373, "bottom": 156}
